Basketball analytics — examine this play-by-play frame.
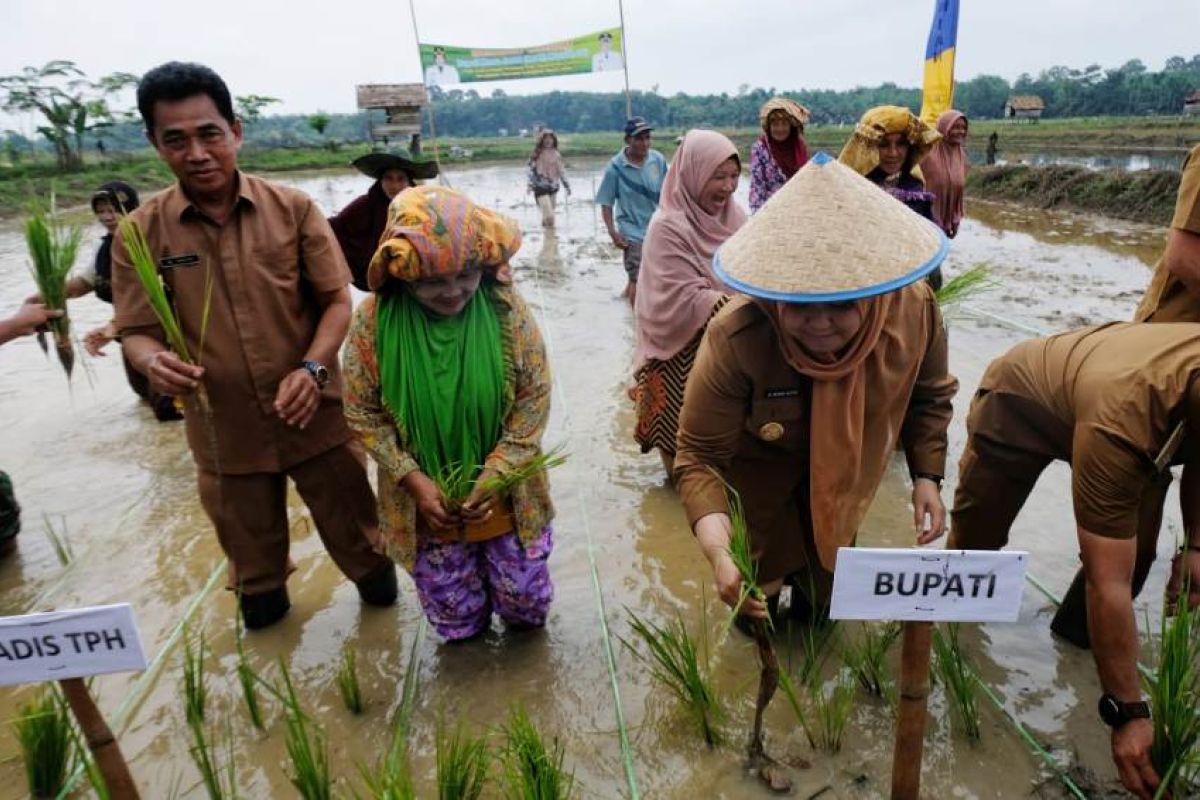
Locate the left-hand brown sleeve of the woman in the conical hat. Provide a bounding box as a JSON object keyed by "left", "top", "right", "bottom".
{"left": 674, "top": 326, "right": 750, "bottom": 525}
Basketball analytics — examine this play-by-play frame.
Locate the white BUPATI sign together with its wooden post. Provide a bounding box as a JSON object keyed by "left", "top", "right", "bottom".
{"left": 829, "top": 547, "right": 1028, "bottom": 800}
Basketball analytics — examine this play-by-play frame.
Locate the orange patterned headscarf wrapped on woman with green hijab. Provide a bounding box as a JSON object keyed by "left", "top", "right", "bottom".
{"left": 367, "top": 186, "right": 521, "bottom": 291}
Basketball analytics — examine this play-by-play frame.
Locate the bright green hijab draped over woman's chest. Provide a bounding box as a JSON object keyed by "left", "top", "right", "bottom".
{"left": 376, "top": 283, "right": 504, "bottom": 477}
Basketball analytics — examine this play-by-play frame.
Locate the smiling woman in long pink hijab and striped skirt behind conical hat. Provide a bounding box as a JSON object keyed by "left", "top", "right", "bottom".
{"left": 634, "top": 130, "right": 746, "bottom": 475}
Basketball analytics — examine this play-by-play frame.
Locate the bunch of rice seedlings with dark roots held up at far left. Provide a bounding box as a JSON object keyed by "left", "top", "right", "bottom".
{"left": 25, "top": 194, "right": 83, "bottom": 379}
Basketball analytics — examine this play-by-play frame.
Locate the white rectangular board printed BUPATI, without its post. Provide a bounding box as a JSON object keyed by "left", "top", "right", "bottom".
{"left": 829, "top": 547, "right": 1028, "bottom": 622}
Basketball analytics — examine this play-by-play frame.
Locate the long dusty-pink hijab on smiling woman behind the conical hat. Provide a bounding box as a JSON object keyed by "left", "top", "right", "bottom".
{"left": 636, "top": 130, "right": 746, "bottom": 367}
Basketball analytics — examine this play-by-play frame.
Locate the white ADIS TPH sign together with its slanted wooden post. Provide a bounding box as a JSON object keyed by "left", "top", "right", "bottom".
{"left": 0, "top": 603, "right": 146, "bottom": 800}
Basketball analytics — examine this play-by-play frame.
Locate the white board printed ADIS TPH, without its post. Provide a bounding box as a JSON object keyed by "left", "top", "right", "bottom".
{"left": 0, "top": 603, "right": 146, "bottom": 686}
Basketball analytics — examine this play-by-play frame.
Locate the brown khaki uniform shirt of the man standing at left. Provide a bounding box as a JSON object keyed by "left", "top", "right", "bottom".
{"left": 113, "top": 173, "right": 350, "bottom": 475}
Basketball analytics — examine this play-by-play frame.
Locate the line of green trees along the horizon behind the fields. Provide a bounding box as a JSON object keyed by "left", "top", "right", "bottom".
{"left": 0, "top": 54, "right": 1200, "bottom": 169}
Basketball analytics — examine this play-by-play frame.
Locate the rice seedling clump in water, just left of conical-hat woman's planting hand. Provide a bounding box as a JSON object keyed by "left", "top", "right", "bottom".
{"left": 622, "top": 608, "right": 725, "bottom": 747}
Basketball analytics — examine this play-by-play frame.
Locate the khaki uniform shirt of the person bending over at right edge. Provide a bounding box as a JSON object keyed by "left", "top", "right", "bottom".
{"left": 979, "top": 323, "right": 1200, "bottom": 539}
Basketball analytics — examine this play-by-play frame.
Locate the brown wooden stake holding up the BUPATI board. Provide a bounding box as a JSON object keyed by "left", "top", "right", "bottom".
{"left": 892, "top": 622, "right": 934, "bottom": 800}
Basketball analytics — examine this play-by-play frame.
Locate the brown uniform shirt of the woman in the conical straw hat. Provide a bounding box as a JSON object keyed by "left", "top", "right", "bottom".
{"left": 676, "top": 285, "right": 958, "bottom": 582}
